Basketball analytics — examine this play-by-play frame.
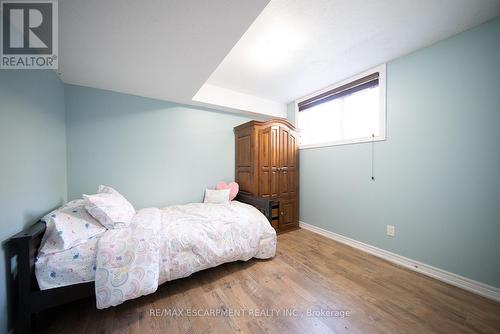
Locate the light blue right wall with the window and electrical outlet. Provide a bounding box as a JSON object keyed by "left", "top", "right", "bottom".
{"left": 292, "top": 19, "right": 500, "bottom": 287}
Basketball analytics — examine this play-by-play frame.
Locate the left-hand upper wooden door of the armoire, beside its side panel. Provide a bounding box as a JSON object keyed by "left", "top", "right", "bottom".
{"left": 259, "top": 126, "right": 279, "bottom": 199}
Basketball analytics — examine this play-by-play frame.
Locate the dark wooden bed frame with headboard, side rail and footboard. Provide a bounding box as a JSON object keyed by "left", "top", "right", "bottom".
{"left": 6, "top": 195, "right": 273, "bottom": 333}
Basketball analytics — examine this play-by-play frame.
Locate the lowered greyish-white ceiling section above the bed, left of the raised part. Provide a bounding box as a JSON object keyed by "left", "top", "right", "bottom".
{"left": 59, "top": 0, "right": 269, "bottom": 103}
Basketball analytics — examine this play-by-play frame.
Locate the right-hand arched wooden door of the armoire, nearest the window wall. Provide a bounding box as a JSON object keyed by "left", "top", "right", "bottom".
{"left": 278, "top": 126, "right": 298, "bottom": 197}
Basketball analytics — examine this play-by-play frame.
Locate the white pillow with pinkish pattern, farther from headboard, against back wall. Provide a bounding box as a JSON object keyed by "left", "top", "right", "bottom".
{"left": 83, "top": 186, "right": 135, "bottom": 229}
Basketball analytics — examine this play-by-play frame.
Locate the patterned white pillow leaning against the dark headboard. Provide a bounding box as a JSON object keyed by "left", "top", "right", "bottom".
{"left": 39, "top": 199, "right": 106, "bottom": 255}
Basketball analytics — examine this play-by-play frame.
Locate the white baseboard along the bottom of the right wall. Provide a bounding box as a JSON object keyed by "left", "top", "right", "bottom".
{"left": 299, "top": 222, "right": 500, "bottom": 302}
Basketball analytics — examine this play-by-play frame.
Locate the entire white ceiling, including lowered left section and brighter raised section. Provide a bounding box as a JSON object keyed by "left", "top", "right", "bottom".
{"left": 59, "top": 0, "right": 500, "bottom": 117}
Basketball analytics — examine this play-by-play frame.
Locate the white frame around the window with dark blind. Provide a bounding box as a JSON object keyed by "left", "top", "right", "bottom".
{"left": 295, "top": 64, "right": 387, "bottom": 149}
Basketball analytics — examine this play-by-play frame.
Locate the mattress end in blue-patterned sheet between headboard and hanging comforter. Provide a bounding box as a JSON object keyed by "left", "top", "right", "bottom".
{"left": 35, "top": 235, "right": 101, "bottom": 290}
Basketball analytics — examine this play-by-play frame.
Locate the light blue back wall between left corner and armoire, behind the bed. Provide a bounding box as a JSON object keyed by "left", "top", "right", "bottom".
{"left": 66, "top": 85, "right": 256, "bottom": 208}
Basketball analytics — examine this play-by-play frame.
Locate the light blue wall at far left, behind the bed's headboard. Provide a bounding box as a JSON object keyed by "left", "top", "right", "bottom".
{"left": 0, "top": 70, "right": 67, "bottom": 332}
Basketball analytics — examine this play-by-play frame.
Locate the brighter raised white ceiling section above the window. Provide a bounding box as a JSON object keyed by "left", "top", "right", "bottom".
{"left": 207, "top": 0, "right": 500, "bottom": 103}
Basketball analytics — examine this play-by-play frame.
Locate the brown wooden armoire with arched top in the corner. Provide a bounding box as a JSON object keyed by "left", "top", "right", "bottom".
{"left": 234, "top": 119, "right": 299, "bottom": 232}
